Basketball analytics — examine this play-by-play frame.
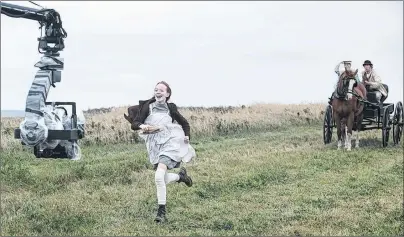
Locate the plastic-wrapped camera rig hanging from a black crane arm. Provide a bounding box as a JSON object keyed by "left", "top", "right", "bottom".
{"left": 0, "top": 2, "right": 84, "bottom": 160}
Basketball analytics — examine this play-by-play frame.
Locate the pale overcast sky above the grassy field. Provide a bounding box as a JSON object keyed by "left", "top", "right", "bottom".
{"left": 1, "top": 1, "right": 403, "bottom": 109}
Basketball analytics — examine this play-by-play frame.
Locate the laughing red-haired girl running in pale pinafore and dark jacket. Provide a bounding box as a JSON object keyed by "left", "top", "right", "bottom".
{"left": 132, "top": 81, "right": 195, "bottom": 223}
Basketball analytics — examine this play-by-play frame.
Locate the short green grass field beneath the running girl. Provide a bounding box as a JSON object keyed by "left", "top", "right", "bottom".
{"left": 1, "top": 126, "right": 404, "bottom": 236}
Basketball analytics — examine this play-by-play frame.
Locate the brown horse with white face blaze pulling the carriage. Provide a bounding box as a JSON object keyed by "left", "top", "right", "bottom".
{"left": 332, "top": 69, "right": 366, "bottom": 151}
